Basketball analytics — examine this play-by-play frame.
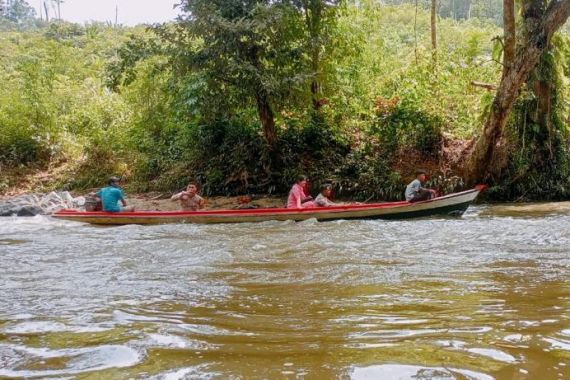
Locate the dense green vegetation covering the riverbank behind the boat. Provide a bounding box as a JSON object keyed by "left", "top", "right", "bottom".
{"left": 0, "top": 0, "right": 570, "bottom": 199}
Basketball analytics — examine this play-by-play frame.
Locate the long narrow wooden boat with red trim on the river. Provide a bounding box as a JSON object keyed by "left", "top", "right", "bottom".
{"left": 53, "top": 186, "right": 484, "bottom": 225}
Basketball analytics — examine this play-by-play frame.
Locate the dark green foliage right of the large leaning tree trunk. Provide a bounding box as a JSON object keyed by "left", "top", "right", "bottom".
{"left": 491, "top": 36, "right": 570, "bottom": 200}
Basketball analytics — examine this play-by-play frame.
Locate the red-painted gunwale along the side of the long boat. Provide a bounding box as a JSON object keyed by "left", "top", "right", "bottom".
{"left": 53, "top": 188, "right": 481, "bottom": 218}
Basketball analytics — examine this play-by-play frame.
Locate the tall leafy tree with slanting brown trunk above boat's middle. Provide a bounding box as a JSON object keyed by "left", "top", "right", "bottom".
{"left": 173, "top": 0, "right": 299, "bottom": 146}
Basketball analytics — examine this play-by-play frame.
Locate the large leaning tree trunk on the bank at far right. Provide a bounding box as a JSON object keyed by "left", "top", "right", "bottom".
{"left": 467, "top": 0, "right": 570, "bottom": 183}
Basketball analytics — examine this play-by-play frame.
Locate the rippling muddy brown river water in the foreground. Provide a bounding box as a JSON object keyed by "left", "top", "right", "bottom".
{"left": 0, "top": 206, "right": 570, "bottom": 379}
